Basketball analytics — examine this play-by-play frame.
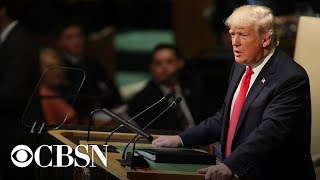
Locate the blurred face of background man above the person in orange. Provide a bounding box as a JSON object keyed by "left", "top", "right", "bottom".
{"left": 59, "top": 25, "right": 85, "bottom": 56}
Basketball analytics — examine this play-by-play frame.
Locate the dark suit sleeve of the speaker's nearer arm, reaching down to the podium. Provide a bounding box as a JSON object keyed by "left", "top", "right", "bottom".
{"left": 223, "top": 75, "right": 310, "bottom": 176}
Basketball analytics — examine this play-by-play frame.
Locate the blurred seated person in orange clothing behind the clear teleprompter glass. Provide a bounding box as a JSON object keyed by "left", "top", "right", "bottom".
{"left": 39, "top": 48, "right": 77, "bottom": 126}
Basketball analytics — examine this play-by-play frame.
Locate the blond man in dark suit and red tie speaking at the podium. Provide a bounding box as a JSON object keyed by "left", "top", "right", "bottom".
{"left": 153, "top": 5, "right": 315, "bottom": 180}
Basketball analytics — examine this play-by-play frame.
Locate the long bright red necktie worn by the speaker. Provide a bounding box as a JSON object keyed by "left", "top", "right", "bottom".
{"left": 226, "top": 66, "right": 253, "bottom": 157}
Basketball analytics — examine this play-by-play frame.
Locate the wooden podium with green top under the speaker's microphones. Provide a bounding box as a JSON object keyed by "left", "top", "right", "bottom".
{"left": 48, "top": 130, "right": 236, "bottom": 180}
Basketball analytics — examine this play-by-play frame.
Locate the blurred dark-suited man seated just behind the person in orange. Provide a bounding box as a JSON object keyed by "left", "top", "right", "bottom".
{"left": 57, "top": 22, "right": 121, "bottom": 123}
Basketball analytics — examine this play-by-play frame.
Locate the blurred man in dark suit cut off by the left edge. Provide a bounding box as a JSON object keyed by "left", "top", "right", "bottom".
{"left": 0, "top": 0, "right": 39, "bottom": 128}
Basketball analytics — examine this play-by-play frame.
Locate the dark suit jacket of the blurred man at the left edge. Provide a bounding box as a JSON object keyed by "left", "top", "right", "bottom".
{"left": 0, "top": 24, "right": 40, "bottom": 125}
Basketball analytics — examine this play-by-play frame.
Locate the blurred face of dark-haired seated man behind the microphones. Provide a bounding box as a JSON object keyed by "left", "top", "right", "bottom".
{"left": 151, "top": 49, "right": 184, "bottom": 83}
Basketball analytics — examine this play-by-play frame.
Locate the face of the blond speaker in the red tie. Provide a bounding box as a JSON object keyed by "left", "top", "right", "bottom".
{"left": 229, "top": 25, "right": 268, "bottom": 66}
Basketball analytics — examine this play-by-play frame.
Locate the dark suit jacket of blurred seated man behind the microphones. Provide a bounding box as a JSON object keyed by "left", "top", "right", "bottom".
{"left": 128, "top": 73, "right": 208, "bottom": 131}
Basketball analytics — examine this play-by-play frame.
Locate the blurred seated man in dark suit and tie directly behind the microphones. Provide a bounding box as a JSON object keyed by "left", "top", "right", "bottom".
{"left": 128, "top": 44, "right": 210, "bottom": 131}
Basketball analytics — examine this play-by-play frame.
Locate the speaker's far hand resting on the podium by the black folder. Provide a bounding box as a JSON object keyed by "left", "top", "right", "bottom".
{"left": 152, "top": 135, "right": 182, "bottom": 147}
